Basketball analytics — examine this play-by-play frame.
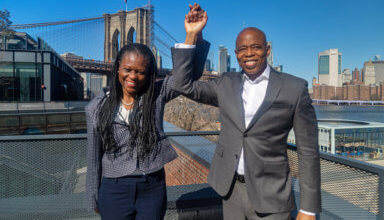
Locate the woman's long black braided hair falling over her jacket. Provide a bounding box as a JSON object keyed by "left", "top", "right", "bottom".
{"left": 97, "top": 43, "right": 158, "bottom": 158}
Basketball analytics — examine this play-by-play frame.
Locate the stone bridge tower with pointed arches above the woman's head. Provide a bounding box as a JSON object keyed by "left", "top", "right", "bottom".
{"left": 103, "top": 6, "right": 153, "bottom": 62}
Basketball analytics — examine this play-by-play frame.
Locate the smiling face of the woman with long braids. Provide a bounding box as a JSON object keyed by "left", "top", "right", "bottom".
{"left": 119, "top": 52, "right": 148, "bottom": 97}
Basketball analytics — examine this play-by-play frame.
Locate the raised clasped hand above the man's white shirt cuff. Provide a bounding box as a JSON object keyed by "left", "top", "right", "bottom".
{"left": 184, "top": 3, "right": 208, "bottom": 45}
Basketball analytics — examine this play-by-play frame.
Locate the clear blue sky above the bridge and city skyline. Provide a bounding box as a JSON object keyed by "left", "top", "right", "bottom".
{"left": 0, "top": 0, "right": 384, "bottom": 85}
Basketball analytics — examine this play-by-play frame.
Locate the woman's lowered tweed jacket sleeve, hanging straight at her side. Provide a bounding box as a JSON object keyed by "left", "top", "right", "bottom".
{"left": 86, "top": 105, "right": 102, "bottom": 211}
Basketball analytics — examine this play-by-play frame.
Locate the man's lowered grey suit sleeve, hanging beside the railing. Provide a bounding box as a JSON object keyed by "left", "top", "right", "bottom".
{"left": 293, "top": 83, "right": 321, "bottom": 213}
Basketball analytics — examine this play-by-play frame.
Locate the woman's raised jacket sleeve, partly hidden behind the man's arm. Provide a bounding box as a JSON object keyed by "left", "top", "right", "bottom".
{"left": 163, "top": 40, "right": 210, "bottom": 102}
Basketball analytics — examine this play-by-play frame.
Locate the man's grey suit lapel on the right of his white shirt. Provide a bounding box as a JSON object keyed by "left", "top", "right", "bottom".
{"left": 243, "top": 67, "right": 282, "bottom": 132}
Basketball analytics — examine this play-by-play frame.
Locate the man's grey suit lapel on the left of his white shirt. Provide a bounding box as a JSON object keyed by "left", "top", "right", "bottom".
{"left": 228, "top": 73, "right": 245, "bottom": 131}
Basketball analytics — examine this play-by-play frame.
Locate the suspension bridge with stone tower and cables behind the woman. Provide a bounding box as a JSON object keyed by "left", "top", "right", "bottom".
{"left": 11, "top": 6, "right": 172, "bottom": 74}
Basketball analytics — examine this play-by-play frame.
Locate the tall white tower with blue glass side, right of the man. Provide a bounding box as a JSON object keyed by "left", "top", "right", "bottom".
{"left": 318, "top": 49, "right": 342, "bottom": 86}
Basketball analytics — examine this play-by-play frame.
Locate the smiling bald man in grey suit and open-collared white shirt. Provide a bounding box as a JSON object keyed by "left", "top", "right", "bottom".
{"left": 172, "top": 5, "right": 321, "bottom": 220}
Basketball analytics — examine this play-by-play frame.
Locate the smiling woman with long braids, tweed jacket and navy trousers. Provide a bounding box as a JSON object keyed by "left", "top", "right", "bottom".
{"left": 86, "top": 5, "right": 208, "bottom": 220}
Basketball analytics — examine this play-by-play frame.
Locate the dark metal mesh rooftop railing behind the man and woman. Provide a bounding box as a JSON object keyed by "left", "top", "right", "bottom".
{"left": 0, "top": 128, "right": 384, "bottom": 220}
